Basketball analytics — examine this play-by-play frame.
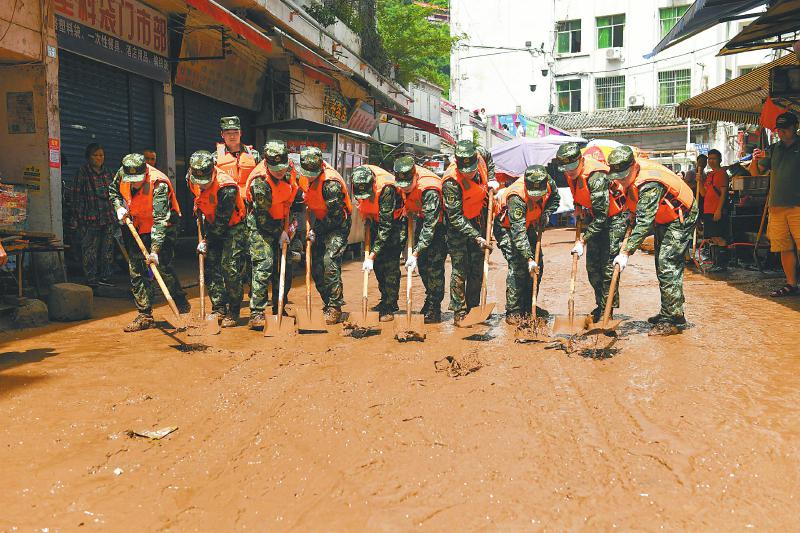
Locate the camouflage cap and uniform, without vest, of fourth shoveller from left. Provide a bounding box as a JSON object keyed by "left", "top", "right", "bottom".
{"left": 300, "top": 148, "right": 352, "bottom": 322}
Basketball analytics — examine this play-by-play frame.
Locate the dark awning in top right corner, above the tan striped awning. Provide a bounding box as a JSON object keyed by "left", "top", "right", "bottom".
{"left": 717, "top": 0, "right": 800, "bottom": 56}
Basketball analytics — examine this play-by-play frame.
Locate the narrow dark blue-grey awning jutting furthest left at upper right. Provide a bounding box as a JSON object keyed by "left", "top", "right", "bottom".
{"left": 644, "top": 0, "right": 767, "bottom": 59}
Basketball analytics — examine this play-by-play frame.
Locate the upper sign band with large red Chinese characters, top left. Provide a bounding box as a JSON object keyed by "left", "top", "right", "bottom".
{"left": 53, "top": 0, "right": 168, "bottom": 56}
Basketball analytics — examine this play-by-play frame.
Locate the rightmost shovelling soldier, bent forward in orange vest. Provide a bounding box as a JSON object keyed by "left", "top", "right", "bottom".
{"left": 608, "top": 146, "right": 698, "bottom": 335}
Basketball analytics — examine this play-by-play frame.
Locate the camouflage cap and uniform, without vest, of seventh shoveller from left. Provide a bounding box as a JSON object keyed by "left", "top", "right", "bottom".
{"left": 442, "top": 141, "right": 487, "bottom": 320}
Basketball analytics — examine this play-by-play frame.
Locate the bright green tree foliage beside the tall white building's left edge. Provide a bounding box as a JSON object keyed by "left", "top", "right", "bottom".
{"left": 377, "top": 0, "right": 459, "bottom": 93}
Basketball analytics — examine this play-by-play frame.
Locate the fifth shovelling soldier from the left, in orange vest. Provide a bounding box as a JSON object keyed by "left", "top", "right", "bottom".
{"left": 352, "top": 165, "right": 407, "bottom": 322}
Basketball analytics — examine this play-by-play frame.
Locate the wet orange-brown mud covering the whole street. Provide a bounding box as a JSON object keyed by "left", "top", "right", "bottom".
{"left": 0, "top": 230, "right": 800, "bottom": 531}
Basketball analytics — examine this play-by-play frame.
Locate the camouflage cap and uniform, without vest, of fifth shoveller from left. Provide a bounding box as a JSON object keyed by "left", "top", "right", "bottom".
{"left": 352, "top": 166, "right": 407, "bottom": 315}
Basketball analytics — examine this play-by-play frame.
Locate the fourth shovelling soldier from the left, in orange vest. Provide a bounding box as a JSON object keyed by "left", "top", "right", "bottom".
{"left": 300, "top": 143, "right": 353, "bottom": 324}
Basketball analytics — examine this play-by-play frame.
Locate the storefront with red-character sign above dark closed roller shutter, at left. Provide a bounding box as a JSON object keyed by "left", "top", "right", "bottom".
{"left": 54, "top": 0, "right": 169, "bottom": 193}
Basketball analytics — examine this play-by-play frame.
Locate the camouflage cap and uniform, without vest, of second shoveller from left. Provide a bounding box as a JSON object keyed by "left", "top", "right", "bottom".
{"left": 189, "top": 150, "right": 247, "bottom": 326}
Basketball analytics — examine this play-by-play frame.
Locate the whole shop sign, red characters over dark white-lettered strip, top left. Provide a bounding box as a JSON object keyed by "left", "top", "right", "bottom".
{"left": 53, "top": 0, "right": 169, "bottom": 81}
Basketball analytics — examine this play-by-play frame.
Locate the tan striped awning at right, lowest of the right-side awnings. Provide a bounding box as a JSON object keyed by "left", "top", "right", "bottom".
{"left": 675, "top": 54, "right": 800, "bottom": 124}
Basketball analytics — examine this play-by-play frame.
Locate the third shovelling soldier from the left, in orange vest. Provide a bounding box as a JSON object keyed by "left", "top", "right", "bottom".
{"left": 246, "top": 141, "right": 298, "bottom": 330}
